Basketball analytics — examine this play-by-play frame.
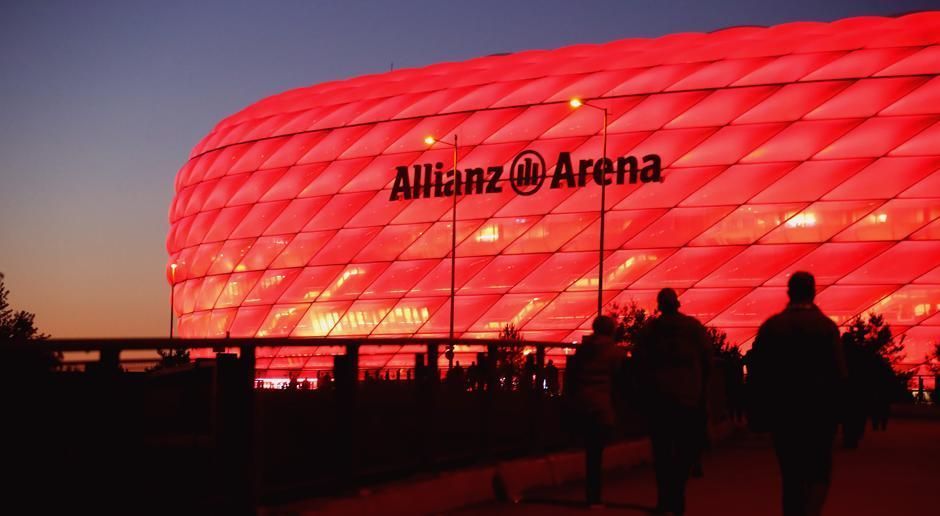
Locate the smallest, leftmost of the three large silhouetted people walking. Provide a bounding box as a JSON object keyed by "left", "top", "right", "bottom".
{"left": 565, "top": 315, "right": 623, "bottom": 506}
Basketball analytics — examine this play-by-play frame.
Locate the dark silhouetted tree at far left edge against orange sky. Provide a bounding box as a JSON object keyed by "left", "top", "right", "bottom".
{"left": 0, "top": 273, "right": 60, "bottom": 372}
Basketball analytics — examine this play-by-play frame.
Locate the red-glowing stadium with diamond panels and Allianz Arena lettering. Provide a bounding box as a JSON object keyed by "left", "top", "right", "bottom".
{"left": 167, "top": 12, "right": 940, "bottom": 377}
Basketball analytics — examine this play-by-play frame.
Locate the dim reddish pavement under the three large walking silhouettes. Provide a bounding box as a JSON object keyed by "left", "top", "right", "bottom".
{"left": 448, "top": 419, "right": 940, "bottom": 516}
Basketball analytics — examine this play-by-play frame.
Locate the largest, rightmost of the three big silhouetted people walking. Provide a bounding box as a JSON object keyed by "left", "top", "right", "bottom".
{"left": 748, "top": 272, "right": 847, "bottom": 516}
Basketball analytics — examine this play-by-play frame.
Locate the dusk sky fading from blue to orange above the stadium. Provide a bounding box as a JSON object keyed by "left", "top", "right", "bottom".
{"left": 0, "top": 0, "right": 940, "bottom": 338}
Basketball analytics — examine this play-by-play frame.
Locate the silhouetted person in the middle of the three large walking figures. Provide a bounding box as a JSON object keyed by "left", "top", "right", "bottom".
{"left": 633, "top": 288, "right": 712, "bottom": 514}
